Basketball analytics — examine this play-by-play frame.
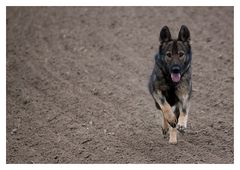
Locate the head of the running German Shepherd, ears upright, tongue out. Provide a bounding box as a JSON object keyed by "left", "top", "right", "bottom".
{"left": 156, "top": 25, "right": 192, "bottom": 83}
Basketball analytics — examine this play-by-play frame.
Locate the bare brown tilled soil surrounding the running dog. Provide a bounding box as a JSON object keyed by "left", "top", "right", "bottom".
{"left": 6, "top": 7, "right": 234, "bottom": 163}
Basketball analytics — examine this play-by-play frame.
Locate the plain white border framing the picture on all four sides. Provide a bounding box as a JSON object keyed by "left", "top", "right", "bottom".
{"left": 0, "top": 0, "right": 240, "bottom": 170}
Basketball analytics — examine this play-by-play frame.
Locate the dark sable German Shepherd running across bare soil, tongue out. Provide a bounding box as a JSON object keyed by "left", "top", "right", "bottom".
{"left": 149, "top": 25, "right": 192, "bottom": 144}
